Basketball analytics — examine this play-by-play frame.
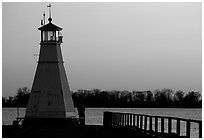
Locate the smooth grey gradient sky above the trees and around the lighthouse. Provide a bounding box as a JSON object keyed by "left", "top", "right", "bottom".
{"left": 2, "top": 2, "right": 202, "bottom": 97}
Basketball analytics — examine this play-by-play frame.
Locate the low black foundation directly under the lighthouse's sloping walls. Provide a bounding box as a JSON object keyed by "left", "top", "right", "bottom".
{"left": 22, "top": 118, "right": 79, "bottom": 126}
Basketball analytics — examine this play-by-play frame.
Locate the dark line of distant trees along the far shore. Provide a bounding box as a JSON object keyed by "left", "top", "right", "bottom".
{"left": 2, "top": 87, "right": 202, "bottom": 108}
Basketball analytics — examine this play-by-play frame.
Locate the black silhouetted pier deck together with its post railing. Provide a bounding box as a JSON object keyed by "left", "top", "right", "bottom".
{"left": 2, "top": 112, "right": 202, "bottom": 138}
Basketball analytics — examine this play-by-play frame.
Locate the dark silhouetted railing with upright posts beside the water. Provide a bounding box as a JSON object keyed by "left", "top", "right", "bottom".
{"left": 103, "top": 112, "right": 202, "bottom": 138}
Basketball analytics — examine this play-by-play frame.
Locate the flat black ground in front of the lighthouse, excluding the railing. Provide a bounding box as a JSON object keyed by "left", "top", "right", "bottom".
{"left": 2, "top": 125, "right": 154, "bottom": 138}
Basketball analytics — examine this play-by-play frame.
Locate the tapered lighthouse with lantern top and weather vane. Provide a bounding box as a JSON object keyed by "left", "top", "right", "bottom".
{"left": 24, "top": 5, "right": 76, "bottom": 123}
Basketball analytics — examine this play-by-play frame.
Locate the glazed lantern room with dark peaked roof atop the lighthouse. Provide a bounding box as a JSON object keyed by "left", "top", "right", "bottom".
{"left": 38, "top": 18, "right": 62, "bottom": 43}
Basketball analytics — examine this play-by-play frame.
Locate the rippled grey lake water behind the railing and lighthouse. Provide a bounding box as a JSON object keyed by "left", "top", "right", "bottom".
{"left": 2, "top": 108, "right": 202, "bottom": 137}
